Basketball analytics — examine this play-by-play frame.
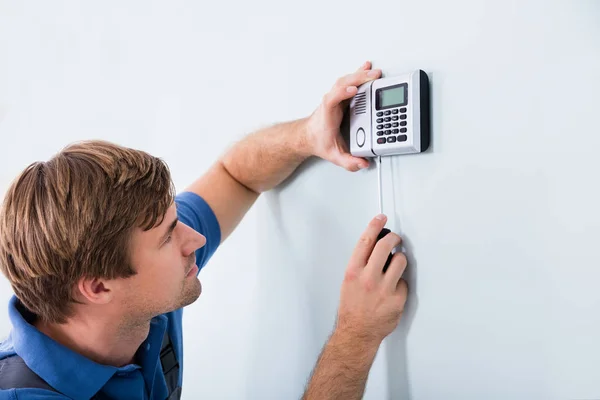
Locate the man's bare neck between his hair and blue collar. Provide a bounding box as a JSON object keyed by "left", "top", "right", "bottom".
{"left": 34, "top": 315, "right": 150, "bottom": 367}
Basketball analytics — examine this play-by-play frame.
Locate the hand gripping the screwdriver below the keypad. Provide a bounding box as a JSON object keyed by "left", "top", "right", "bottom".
{"left": 335, "top": 215, "right": 408, "bottom": 346}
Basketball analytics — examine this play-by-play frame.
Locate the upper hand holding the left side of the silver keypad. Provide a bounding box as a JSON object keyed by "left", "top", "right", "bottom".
{"left": 306, "top": 61, "right": 381, "bottom": 172}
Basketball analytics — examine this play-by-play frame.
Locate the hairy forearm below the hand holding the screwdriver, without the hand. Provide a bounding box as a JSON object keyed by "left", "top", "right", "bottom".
{"left": 302, "top": 332, "right": 379, "bottom": 400}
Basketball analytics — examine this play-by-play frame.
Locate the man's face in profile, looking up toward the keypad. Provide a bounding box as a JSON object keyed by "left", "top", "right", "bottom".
{"left": 119, "top": 204, "right": 206, "bottom": 318}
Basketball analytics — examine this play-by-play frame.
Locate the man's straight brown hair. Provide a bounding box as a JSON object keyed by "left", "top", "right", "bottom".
{"left": 0, "top": 141, "right": 175, "bottom": 323}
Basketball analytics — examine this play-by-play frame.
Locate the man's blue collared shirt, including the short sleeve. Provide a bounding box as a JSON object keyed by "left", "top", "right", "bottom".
{"left": 0, "top": 192, "right": 221, "bottom": 400}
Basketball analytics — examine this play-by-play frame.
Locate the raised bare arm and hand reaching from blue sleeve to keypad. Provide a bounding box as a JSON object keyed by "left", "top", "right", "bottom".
{"left": 186, "top": 62, "right": 381, "bottom": 242}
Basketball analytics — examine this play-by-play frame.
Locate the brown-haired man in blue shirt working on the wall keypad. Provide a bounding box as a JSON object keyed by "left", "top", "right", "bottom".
{"left": 0, "top": 62, "right": 407, "bottom": 400}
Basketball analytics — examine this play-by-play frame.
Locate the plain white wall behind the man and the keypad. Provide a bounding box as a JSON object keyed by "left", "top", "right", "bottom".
{"left": 0, "top": 0, "right": 600, "bottom": 399}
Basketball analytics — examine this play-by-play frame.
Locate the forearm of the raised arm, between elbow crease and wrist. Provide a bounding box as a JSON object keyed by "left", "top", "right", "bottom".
{"left": 222, "top": 119, "right": 311, "bottom": 194}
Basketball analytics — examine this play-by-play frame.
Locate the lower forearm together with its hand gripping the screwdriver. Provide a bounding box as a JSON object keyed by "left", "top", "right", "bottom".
{"left": 303, "top": 216, "right": 408, "bottom": 400}
